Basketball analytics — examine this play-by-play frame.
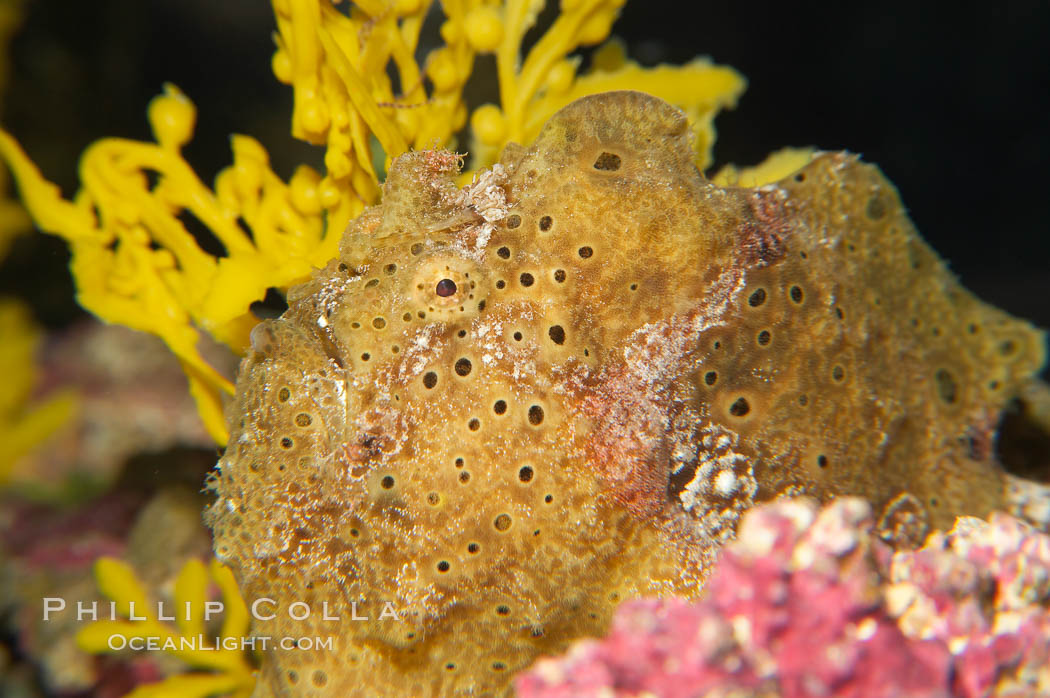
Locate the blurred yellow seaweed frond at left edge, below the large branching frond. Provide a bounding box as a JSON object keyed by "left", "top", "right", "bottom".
{"left": 0, "top": 298, "right": 77, "bottom": 485}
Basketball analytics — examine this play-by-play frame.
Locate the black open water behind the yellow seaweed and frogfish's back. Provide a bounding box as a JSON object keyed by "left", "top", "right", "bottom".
{"left": 0, "top": 0, "right": 1050, "bottom": 340}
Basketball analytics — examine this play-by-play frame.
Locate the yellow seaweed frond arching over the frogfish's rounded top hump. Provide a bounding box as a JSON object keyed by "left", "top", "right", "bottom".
{"left": 470, "top": 27, "right": 747, "bottom": 170}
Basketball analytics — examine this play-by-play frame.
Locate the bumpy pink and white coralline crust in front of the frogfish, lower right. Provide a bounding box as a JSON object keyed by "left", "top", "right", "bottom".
{"left": 517, "top": 499, "right": 1050, "bottom": 698}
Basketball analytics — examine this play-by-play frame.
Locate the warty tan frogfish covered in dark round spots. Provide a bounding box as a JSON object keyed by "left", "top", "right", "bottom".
{"left": 207, "top": 91, "right": 1050, "bottom": 697}
